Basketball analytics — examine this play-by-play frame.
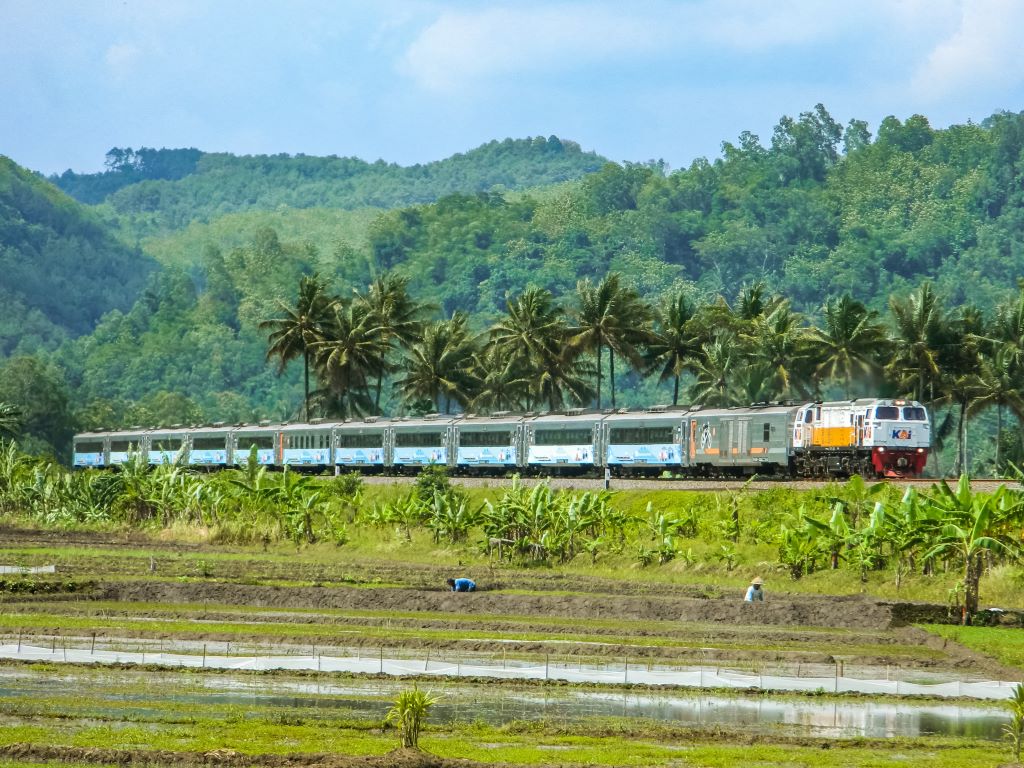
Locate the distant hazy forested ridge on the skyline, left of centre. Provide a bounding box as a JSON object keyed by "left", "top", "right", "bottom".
{"left": 51, "top": 136, "right": 605, "bottom": 232}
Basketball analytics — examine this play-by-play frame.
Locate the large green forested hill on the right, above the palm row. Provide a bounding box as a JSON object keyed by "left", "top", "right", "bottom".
{"left": 369, "top": 105, "right": 1024, "bottom": 316}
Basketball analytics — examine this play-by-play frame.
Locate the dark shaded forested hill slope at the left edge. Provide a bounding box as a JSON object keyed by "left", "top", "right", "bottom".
{"left": 0, "top": 156, "right": 155, "bottom": 357}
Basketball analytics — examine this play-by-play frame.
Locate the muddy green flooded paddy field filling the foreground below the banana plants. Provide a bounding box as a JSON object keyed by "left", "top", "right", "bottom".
{"left": 0, "top": 536, "right": 1021, "bottom": 768}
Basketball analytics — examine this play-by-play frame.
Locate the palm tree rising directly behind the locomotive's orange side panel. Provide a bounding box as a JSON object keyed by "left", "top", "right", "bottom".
{"left": 808, "top": 294, "right": 889, "bottom": 399}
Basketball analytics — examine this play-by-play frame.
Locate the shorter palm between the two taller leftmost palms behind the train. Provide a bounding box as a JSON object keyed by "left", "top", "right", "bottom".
{"left": 312, "top": 300, "right": 388, "bottom": 416}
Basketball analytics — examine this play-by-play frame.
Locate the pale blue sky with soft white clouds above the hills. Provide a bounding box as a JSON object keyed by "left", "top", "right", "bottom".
{"left": 0, "top": 0, "right": 1024, "bottom": 174}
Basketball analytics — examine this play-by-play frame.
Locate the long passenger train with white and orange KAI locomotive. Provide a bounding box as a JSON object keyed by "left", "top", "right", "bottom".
{"left": 73, "top": 398, "right": 931, "bottom": 477}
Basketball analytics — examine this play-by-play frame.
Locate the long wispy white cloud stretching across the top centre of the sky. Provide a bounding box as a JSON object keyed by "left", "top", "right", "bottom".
{"left": 398, "top": 0, "right": 887, "bottom": 91}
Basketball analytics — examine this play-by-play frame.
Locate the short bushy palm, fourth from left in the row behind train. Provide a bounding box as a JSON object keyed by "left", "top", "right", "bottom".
{"left": 395, "top": 312, "right": 475, "bottom": 413}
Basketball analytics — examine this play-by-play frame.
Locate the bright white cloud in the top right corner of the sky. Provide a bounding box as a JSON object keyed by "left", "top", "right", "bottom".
{"left": 912, "top": 0, "right": 1024, "bottom": 98}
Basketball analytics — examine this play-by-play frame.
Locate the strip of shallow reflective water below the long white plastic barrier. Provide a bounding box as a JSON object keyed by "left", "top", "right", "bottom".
{"left": 0, "top": 673, "right": 1009, "bottom": 740}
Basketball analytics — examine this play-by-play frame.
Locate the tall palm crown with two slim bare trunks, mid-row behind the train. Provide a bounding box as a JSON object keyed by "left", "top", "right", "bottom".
{"left": 569, "top": 272, "right": 652, "bottom": 409}
